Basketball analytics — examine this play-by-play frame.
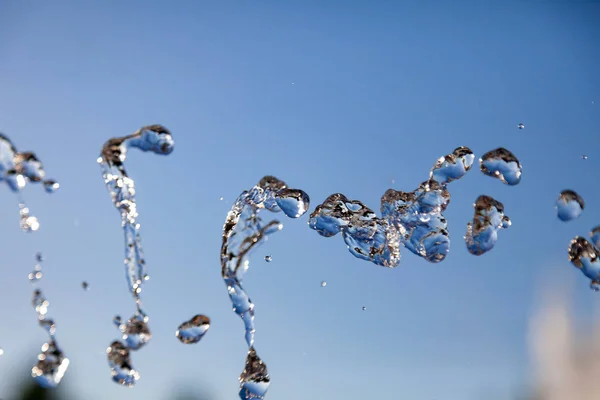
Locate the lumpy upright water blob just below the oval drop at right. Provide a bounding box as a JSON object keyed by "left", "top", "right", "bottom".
{"left": 465, "top": 195, "right": 511, "bottom": 256}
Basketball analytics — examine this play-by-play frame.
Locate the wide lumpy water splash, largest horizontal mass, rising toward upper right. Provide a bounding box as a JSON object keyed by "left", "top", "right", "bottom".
{"left": 309, "top": 146, "right": 475, "bottom": 268}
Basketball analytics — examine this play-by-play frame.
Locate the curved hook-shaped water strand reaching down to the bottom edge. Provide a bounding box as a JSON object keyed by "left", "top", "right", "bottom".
{"left": 221, "top": 176, "right": 310, "bottom": 399}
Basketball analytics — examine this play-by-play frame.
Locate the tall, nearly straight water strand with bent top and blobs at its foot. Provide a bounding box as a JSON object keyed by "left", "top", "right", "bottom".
{"left": 97, "top": 125, "right": 175, "bottom": 387}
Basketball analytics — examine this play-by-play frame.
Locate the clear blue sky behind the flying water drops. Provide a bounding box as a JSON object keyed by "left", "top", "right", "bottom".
{"left": 0, "top": 0, "right": 600, "bottom": 400}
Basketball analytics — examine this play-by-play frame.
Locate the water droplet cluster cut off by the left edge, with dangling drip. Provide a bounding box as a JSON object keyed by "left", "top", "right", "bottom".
{"left": 0, "top": 133, "right": 60, "bottom": 232}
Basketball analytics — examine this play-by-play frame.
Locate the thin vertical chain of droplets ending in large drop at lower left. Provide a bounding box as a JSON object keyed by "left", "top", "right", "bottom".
{"left": 29, "top": 253, "right": 69, "bottom": 388}
